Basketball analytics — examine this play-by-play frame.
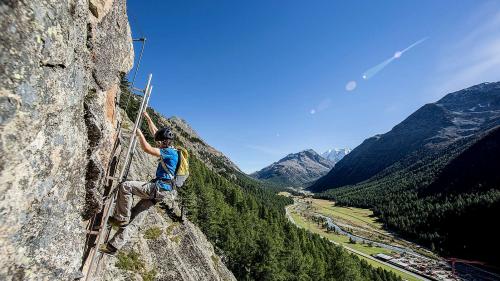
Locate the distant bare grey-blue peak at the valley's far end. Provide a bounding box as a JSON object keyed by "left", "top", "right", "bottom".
{"left": 251, "top": 149, "right": 334, "bottom": 187}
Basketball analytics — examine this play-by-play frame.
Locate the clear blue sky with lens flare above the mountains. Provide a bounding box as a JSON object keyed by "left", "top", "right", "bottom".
{"left": 128, "top": 0, "right": 500, "bottom": 172}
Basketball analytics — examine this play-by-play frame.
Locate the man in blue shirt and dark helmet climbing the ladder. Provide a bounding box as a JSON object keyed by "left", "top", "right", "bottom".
{"left": 100, "top": 112, "right": 179, "bottom": 255}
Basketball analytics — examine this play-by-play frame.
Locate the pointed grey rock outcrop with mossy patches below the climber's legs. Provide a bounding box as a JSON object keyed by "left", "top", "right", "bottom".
{"left": 100, "top": 210, "right": 236, "bottom": 281}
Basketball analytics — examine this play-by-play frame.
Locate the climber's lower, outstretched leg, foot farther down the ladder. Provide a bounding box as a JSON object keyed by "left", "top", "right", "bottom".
{"left": 109, "top": 199, "right": 155, "bottom": 250}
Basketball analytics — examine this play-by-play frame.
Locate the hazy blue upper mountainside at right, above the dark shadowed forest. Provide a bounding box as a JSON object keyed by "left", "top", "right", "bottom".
{"left": 310, "top": 82, "right": 500, "bottom": 192}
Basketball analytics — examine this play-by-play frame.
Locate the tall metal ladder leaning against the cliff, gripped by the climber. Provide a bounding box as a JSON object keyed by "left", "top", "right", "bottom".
{"left": 77, "top": 35, "right": 153, "bottom": 281}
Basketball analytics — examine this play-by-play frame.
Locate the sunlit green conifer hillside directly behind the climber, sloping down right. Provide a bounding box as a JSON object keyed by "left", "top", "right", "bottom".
{"left": 120, "top": 79, "right": 398, "bottom": 280}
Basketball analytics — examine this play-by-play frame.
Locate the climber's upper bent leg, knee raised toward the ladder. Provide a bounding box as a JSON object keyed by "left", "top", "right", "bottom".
{"left": 113, "top": 181, "right": 154, "bottom": 222}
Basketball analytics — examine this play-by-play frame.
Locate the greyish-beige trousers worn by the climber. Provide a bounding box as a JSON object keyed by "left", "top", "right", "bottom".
{"left": 109, "top": 181, "right": 169, "bottom": 250}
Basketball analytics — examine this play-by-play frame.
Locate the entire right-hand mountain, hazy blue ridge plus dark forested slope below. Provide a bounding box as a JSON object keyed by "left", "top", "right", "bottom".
{"left": 309, "top": 82, "right": 500, "bottom": 267}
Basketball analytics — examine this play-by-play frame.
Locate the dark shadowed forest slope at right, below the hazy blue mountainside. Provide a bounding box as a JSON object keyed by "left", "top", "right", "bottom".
{"left": 321, "top": 127, "right": 500, "bottom": 266}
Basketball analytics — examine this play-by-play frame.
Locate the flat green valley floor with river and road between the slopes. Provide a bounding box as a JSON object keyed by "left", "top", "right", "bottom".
{"left": 281, "top": 193, "right": 458, "bottom": 280}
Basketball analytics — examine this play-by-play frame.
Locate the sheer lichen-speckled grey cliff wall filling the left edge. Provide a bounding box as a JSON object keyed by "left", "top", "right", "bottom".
{"left": 0, "top": 0, "right": 133, "bottom": 280}
